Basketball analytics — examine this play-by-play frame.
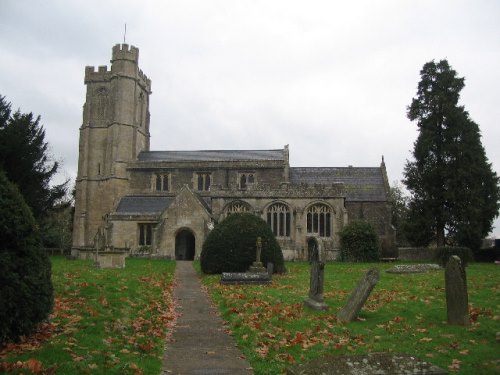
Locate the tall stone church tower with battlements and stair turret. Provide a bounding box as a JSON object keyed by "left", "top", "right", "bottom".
{"left": 73, "top": 44, "right": 151, "bottom": 250}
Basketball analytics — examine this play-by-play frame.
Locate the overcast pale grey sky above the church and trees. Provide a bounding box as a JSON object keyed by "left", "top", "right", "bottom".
{"left": 0, "top": 0, "right": 500, "bottom": 237}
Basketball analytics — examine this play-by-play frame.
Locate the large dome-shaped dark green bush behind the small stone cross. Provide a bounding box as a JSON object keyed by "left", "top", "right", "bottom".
{"left": 200, "top": 213, "right": 285, "bottom": 273}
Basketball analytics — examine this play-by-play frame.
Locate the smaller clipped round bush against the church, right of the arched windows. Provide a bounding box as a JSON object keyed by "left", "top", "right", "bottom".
{"left": 340, "top": 220, "right": 380, "bottom": 262}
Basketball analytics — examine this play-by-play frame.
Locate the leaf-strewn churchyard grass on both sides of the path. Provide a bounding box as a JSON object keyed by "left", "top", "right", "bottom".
{"left": 0, "top": 257, "right": 500, "bottom": 374}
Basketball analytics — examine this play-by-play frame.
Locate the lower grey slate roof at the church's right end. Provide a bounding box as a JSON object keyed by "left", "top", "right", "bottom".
{"left": 290, "top": 167, "right": 387, "bottom": 202}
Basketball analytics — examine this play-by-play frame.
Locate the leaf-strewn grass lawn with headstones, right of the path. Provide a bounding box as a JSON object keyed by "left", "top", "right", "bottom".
{"left": 198, "top": 263, "right": 500, "bottom": 374}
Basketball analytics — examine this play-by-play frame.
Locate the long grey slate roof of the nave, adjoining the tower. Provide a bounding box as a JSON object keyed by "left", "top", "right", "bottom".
{"left": 138, "top": 150, "right": 283, "bottom": 162}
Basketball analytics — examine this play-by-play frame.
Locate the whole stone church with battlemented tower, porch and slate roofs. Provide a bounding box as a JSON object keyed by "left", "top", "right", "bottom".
{"left": 72, "top": 44, "right": 394, "bottom": 260}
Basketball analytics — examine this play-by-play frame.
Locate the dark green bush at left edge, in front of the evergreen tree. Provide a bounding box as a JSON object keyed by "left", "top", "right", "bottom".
{"left": 0, "top": 171, "right": 53, "bottom": 344}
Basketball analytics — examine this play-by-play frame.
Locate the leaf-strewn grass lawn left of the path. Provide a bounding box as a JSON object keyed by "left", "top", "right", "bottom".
{"left": 0, "top": 257, "right": 175, "bottom": 375}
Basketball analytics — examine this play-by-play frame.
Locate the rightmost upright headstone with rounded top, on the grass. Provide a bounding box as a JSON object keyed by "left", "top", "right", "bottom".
{"left": 444, "top": 255, "right": 470, "bottom": 325}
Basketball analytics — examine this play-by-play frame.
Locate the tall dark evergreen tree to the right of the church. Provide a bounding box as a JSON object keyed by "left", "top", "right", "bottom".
{"left": 404, "top": 60, "right": 500, "bottom": 249}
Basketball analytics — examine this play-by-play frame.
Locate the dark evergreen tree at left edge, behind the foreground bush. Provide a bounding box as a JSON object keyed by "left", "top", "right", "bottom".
{"left": 0, "top": 95, "right": 67, "bottom": 221}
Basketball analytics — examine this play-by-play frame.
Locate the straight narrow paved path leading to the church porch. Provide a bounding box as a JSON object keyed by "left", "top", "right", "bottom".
{"left": 162, "top": 261, "right": 253, "bottom": 375}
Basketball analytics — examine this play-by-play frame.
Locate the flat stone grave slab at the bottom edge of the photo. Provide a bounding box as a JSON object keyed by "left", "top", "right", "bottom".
{"left": 286, "top": 353, "right": 447, "bottom": 375}
